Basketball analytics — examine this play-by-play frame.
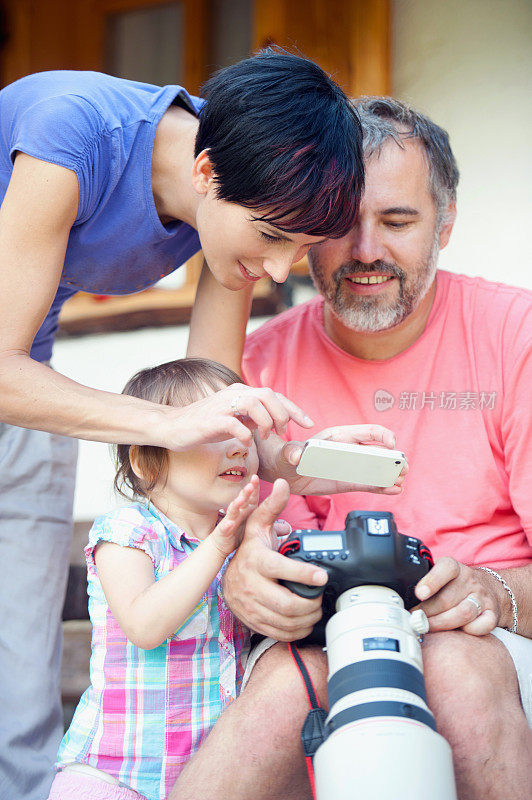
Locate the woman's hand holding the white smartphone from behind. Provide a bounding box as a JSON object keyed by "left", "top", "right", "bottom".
{"left": 258, "top": 425, "right": 408, "bottom": 495}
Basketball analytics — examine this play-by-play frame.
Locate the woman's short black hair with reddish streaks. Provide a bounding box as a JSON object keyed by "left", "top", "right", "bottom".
{"left": 195, "top": 48, "right": 364, "bottom": 238}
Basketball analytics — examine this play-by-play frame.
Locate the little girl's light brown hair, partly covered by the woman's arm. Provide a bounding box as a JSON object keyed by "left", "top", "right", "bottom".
{"left": 114, "top": 358, "right": 242, "bottom": 499}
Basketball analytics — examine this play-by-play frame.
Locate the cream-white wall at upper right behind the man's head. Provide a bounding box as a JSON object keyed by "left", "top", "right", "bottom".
{"left": 392, "top": 0, "right": 532, "bottom": 289}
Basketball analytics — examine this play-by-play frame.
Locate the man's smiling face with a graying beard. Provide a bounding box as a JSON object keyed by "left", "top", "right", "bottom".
{"left": 309, "top": 139, "right": 452, "bottom": 333}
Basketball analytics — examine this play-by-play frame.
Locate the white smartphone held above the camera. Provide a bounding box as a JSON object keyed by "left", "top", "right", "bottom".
{"left": 296, "top": 439, "right": 406, "bottom": 488}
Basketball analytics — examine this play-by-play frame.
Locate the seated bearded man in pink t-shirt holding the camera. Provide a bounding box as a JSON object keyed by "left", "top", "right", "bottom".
{"left": 175, "top": 98, "right": 532, "bottom": 800}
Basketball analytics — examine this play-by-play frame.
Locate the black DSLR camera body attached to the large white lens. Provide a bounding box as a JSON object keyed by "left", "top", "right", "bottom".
{"left": 279, "top": 511, "right": 434, "bottom": 644}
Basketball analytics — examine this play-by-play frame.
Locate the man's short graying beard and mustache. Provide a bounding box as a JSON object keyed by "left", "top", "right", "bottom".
{"left": 309, "top": 231, "right": 440, "bottom": 333}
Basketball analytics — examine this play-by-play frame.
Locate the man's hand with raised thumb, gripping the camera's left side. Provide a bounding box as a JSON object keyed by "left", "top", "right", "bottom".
{"left": 224, "top": 480, "right": 328, "bottom": 642}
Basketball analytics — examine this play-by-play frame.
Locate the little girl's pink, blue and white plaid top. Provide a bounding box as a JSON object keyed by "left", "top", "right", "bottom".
{"left": 57, "top": 503, "right": 249, "bottom": 800}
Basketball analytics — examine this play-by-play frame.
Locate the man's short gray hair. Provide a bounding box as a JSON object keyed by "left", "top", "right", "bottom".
{"left": 353, "top": 97, "right": 459, "bottom": 219}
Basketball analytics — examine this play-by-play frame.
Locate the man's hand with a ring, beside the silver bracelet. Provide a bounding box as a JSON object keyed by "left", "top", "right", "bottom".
{"left": 416, "top": 557, "right": 506, "bottom": 636}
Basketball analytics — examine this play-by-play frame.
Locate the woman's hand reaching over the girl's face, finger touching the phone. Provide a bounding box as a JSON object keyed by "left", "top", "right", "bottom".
{"left": 149, "top": 383, "right": 314, "bottom": 451}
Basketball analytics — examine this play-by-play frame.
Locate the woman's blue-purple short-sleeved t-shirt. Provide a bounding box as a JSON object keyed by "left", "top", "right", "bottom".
{"left": 0, "top": 71, "right": 202, "bottom": 361}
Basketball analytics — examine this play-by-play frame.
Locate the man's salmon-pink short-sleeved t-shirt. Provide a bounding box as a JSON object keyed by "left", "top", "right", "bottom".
{"left": 244, "top": 271, "right": 532, "bottom": 568}
